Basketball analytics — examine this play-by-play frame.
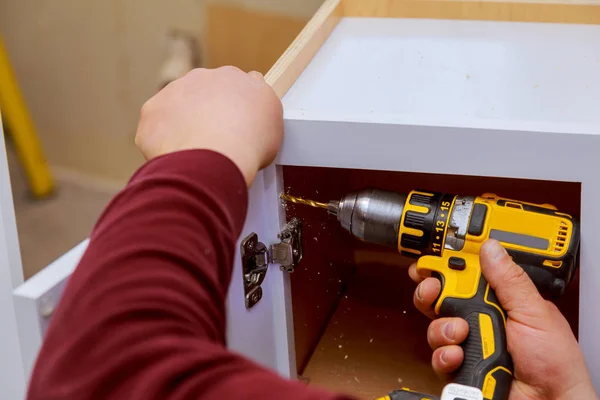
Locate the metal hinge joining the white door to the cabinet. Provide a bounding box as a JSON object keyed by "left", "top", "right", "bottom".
{"left": 241, "top": 218, "right": 302, "bottom": 308}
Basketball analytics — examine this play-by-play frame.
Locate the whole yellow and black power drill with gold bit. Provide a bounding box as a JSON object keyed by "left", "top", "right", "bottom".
{"left": 284, "top": 189, "right": 579, "bottom": 400}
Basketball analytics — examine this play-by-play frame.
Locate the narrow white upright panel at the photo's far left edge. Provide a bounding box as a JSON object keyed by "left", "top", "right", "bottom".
{"left": 0, "top": 118, "right": 25, "bottom": 400}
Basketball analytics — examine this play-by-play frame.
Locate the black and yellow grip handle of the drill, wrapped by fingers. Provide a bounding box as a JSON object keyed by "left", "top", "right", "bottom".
{"left": 439, "top": 275, "right": 513, "bottom": 400}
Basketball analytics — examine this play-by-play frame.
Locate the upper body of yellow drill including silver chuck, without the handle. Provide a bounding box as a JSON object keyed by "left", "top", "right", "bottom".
{"left": 334, "top": 189, "right": 580, "bottom": 298}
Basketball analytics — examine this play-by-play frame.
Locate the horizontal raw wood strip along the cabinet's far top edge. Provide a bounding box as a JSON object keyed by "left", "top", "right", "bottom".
{"left": 342, "top": 0, "right": 600, "bottom": 24}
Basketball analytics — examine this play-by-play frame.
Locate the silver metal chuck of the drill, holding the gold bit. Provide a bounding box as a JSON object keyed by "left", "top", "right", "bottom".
{"left": 329, "top": 189, "right": 406, "bottom": 248}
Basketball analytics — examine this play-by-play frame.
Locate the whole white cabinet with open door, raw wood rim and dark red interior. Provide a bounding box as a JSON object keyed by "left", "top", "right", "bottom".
{"left": 3, "top": 0, "right": 600, "bottom": 396}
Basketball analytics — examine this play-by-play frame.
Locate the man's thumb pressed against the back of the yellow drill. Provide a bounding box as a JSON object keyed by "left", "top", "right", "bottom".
{"left": 480, "top": 239, "right": 543, "bottom": 313}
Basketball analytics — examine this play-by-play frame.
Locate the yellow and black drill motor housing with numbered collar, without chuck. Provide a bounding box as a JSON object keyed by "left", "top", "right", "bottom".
{"left": 398, "top": 191, "right": 579, "bottom": 297}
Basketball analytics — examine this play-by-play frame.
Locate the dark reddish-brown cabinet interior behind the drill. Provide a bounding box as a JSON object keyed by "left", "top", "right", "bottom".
{"left": 282, "top": 166, "right": 581, "bottom": 399}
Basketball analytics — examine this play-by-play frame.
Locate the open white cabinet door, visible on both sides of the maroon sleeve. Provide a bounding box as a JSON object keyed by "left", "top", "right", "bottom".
{"left": 12, "top": 166, "right": 295, "bottom": 398}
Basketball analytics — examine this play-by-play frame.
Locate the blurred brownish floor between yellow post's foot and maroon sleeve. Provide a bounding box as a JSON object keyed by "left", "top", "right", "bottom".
{"left": 7, "top": 143, "right": 117, "bottom": 279}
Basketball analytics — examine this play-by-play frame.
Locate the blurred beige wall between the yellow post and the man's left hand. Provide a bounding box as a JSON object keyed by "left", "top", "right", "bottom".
{"left": 0, "top": 0, "right": 202, "bottom": 180}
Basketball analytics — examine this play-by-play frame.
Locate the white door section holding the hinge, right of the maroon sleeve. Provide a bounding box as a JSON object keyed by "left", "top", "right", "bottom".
{"left": 227, "top": 167, "right": 296, "bottom": 378}
